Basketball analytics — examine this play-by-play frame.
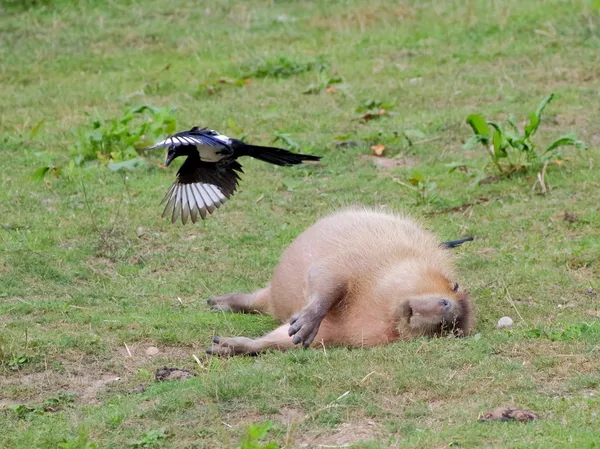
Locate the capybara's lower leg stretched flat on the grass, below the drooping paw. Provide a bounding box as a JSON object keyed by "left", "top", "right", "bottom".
{"left": 206, "top": 324, "right": 294, "bottom": 355}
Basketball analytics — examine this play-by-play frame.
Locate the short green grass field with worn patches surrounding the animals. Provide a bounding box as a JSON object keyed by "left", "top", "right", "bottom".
{"left": 0, "top": 0, "right": 600, "bottom": 448}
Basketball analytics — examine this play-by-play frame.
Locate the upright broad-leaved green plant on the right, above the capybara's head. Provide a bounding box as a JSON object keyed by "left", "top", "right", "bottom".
{"left": 465, "top": 94, "right": 587, "bottom": 174}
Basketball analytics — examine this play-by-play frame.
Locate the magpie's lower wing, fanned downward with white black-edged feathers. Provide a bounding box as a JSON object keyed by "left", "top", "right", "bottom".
{"left": 161, "top": 156, "right": 243, "bottom": 224}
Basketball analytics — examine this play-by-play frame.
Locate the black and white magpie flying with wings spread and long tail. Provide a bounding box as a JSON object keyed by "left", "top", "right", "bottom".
{"left": 140, "top": 126, "right": 321, "bottom": 224}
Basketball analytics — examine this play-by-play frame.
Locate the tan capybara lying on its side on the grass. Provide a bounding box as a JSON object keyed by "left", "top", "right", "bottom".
{"left": 207, "top": 207, "right": 474, "bottom": 355}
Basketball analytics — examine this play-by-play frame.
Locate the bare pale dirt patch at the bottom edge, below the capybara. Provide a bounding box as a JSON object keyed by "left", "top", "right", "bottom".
{"left": 293, "top": 421, "right": 382, "bottom": 448}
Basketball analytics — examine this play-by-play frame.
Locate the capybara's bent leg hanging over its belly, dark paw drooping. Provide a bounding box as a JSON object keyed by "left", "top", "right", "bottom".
{"left": 288, "top": 266, "right": 347, "bottom": 348}
